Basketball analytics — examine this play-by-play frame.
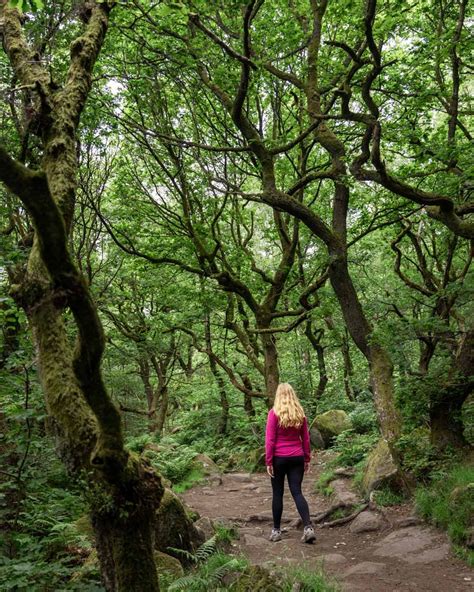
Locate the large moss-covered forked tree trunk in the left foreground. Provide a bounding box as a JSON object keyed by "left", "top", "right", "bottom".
{"left": 0, "top": 2, "right": 163, "bottom": 592}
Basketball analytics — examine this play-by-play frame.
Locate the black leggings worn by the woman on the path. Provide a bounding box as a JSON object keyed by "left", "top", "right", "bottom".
{"left": 272, "top": 456, "right": 311, "bottom": 528}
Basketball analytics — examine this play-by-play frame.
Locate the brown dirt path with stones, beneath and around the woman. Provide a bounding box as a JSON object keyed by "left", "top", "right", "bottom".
{"left": 182, "top": 453, "right": 474, "bottom": 592}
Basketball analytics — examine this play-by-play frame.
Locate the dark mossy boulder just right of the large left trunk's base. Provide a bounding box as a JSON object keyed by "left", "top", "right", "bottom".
{"left": 155, "top": 489, "right": 203, "bottom": 561}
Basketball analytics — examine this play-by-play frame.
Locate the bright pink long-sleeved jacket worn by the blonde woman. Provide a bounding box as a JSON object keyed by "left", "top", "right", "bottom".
{"left": 265, "top": 409, "right": 311, "bottom": 466}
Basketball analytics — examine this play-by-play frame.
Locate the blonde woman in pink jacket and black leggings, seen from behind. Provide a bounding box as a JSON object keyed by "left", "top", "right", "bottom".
{"left": 265, "top": 383, "right": 316, "bottom": 543}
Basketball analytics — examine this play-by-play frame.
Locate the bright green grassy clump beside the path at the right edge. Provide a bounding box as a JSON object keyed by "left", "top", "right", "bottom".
{"left": 415, "top": 464, "right": 474, "bottom": 545}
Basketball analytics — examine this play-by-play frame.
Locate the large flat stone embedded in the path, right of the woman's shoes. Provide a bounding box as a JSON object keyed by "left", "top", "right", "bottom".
{"left": 374, "top": 526, "right": 449, "bottom": 563}
